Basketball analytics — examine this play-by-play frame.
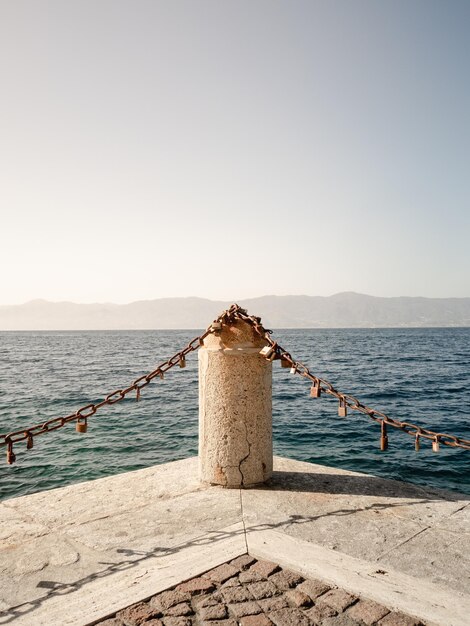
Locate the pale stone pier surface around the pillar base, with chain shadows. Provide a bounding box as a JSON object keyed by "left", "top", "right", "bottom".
{"left": 0, "top": 458, "right": 470, "bottom": 626}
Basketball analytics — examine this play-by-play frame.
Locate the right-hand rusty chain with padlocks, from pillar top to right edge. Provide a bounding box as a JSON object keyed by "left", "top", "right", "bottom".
{"left": 220, "top": 304, "right": 470, "bottom": 452}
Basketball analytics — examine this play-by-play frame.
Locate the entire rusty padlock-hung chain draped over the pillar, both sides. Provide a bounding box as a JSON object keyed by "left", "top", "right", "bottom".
{"left": 0, "top": 304, "right": 470, "bottom": 464}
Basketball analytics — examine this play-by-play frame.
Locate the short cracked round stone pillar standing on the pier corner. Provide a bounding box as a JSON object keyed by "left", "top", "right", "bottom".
{"left": 199, "top": 320, "right": 273, "bottom": 487}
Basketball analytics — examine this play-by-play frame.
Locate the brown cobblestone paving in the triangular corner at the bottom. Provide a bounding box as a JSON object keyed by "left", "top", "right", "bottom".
{"left": 99, "top": 554, "right": 424, "bottom": 626}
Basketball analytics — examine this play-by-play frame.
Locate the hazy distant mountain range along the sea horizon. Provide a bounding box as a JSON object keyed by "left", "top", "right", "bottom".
{"left": 0, "top": 292, "right": 470, "bottom": 330}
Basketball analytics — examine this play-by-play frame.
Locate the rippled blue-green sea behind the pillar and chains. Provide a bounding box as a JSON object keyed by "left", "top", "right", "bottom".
{"left": 0, "top": 328, "right": 470, "bottom": 499}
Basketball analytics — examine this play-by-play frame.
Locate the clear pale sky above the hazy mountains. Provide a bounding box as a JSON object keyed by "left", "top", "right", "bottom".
{"left": 0, "top": 0, "right": 470, "bottom": 304}
